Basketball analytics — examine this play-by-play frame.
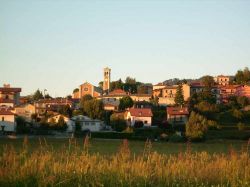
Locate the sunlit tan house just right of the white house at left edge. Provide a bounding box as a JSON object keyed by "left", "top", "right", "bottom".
{"left": 14, "top": 104, "right": 36, "bottom": 121}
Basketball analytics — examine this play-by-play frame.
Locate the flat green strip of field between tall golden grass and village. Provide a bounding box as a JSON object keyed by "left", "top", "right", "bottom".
{"left": 0, "top": 138, "right": 247, "bottom": 155}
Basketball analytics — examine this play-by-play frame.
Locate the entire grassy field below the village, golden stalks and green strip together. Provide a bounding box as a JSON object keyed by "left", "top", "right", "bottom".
{"left": 0, "top": 138, "right": 250, "bottom": 187}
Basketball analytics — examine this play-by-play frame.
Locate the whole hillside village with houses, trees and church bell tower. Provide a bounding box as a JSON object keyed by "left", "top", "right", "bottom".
{"left": 0, "top": 68, "right": 250, "bottom": 141}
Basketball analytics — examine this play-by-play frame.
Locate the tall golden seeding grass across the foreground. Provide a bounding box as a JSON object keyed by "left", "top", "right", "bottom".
{"left": 0, "top": 138, "right": 250, "bottom": 187}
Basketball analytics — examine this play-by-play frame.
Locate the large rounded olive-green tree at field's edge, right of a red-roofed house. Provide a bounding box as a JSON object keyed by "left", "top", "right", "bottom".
{"left": 186, "top": 112, "right": 208, "bottom": 139}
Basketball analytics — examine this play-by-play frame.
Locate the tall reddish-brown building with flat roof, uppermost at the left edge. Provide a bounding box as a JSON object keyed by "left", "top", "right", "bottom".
{"left": 0, "top": 84, "right": 21, "bottom": 107}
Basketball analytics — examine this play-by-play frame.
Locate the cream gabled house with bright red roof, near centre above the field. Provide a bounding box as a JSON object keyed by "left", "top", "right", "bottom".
{"left": 125, "top": 108, "right": 153, "bottom": 127}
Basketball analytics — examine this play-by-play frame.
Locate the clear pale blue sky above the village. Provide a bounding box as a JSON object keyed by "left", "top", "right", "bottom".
{"left": 0, "top": 0, "right": 250, "bottom": 97}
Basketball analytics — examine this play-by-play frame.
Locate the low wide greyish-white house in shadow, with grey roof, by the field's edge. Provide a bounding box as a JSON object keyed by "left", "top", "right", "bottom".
{"left": 71, "top": 115, "right": 104, "bottom": 132}
